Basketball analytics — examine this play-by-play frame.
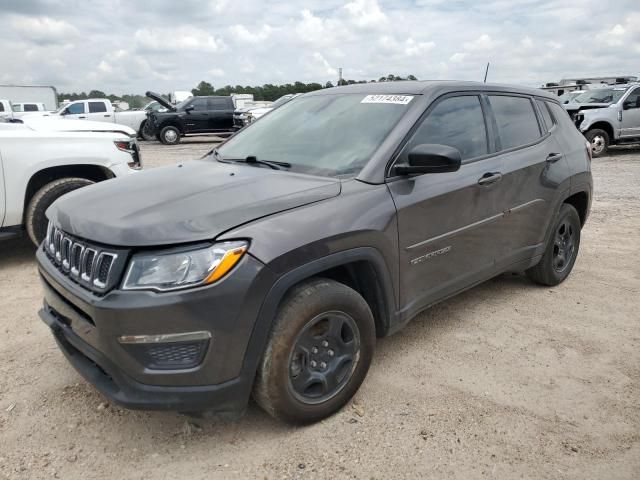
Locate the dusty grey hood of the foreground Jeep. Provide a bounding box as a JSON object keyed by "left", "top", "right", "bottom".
{"left": 47, "top": 160, "right": 341, "bottom": 247}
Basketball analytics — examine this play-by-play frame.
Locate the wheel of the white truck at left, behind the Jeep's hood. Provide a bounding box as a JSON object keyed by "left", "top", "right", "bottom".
{"left": 25, "top": 178, "right": 94, "bottom": 246}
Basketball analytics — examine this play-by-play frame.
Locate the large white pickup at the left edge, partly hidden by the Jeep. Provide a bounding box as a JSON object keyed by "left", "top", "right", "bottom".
{"left": 0, "top": 119, "right": 141, "bottom": 244}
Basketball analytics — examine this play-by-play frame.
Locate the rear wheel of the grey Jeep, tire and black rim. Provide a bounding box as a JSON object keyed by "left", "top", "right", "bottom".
{"left": 526, "top": 203, "right": 581, "bottom": 287}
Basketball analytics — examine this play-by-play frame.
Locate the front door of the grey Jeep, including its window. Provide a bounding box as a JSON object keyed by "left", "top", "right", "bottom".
{"left": 388, "top": 95, "right": 504, "bottom": 316}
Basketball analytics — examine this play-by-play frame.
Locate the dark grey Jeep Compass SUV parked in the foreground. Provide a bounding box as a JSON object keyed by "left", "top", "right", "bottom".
{"left": 37, "top": 82, "right": 592, "bottom": 423}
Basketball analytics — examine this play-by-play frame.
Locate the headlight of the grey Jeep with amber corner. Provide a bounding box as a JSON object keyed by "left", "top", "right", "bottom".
{"left": 122, "top": 241, "right": 249, "bottom": 291}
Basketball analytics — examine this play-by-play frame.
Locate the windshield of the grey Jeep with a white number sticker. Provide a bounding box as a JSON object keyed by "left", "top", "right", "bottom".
{"left": 219, "top": 94, "right": 413, "bottom": 176}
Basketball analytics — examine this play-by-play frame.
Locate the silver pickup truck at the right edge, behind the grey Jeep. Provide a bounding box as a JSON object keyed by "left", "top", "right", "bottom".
{"left": 564, "top": 83, "right": 640, "bottom": 157}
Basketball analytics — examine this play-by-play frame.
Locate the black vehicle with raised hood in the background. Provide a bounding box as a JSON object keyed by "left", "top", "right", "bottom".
{"left": 145, "top": 92, "right": 238, "bottom": 145}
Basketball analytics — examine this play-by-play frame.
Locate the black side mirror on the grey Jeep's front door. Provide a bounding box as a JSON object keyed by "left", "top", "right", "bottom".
{"left": 395, "top": 143, "right": 462, "bottom": 175}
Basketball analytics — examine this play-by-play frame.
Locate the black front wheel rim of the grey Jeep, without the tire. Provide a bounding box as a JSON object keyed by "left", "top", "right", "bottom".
{"left": 288, "top": 311, "right": 360, "bottom": 404}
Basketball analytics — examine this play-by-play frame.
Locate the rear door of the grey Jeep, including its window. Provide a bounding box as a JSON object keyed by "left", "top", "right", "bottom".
{"left": 488, "top": 93, "right": 568, "bottom": 270}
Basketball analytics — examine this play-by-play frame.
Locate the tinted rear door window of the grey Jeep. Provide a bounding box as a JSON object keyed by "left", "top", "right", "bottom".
{"left": 489, "top": 95, "right": 540, "bottom": 150}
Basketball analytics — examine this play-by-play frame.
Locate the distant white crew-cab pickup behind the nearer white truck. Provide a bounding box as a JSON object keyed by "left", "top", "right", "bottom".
{"left": 22, "top": 98, "right": 147, "bottom": 139}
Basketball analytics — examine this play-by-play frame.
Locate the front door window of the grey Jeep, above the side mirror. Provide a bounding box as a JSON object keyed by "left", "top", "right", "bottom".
{"left": 405, "top": 96, "right": 488, "bottom": 160}
